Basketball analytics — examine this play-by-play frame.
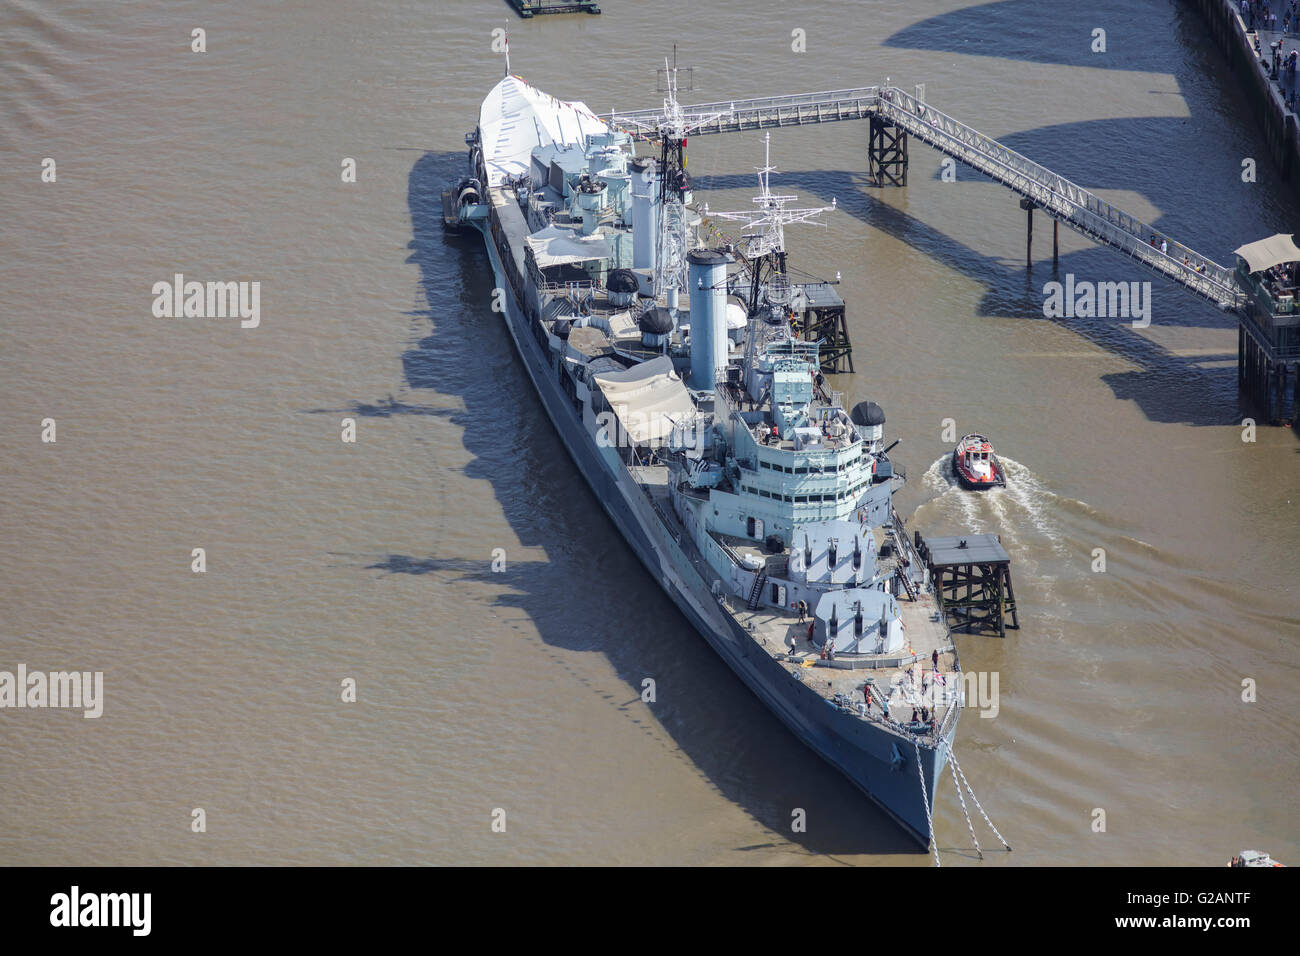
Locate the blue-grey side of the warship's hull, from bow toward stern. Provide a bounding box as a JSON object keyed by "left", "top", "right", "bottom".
{"left": 481, "top": 214, "right": 957, "bottom": 847}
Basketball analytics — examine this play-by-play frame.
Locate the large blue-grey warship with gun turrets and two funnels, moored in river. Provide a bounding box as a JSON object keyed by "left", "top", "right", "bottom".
{"left": 442, "top": 61, "right": 974, "bottom": 860}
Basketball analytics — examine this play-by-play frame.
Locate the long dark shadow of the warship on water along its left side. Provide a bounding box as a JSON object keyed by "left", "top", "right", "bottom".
{"left": 395, "top": 152, "right": 915, "bottom": 860}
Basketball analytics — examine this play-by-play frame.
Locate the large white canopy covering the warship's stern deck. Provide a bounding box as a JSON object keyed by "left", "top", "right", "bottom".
{"left": 478, "top": 77, "right": 610, "bottom": 186}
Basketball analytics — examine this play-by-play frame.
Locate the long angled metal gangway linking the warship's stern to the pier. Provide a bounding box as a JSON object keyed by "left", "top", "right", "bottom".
{"left": 608, "top": 86, "right": 1245, "bottom": 311}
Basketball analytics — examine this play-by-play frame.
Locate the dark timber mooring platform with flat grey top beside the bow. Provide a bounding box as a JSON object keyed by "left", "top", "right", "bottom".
{"left": 914, "top": 531, "right": 1021, "bottom": 637}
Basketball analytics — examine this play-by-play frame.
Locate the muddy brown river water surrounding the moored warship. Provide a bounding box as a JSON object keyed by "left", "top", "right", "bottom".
{"left": 0, "top": 0, "right": 1300, "bottom": 866}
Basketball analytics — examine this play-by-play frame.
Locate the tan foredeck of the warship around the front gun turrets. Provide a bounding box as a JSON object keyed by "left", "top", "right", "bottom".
{"left": 631, "top": 466, "right": 962, "bottom": 744}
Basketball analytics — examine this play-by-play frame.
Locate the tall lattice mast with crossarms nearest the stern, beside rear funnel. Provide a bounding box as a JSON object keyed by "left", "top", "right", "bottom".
{"left": 610, "top": 57, "right": 732, "bottom": 308}
